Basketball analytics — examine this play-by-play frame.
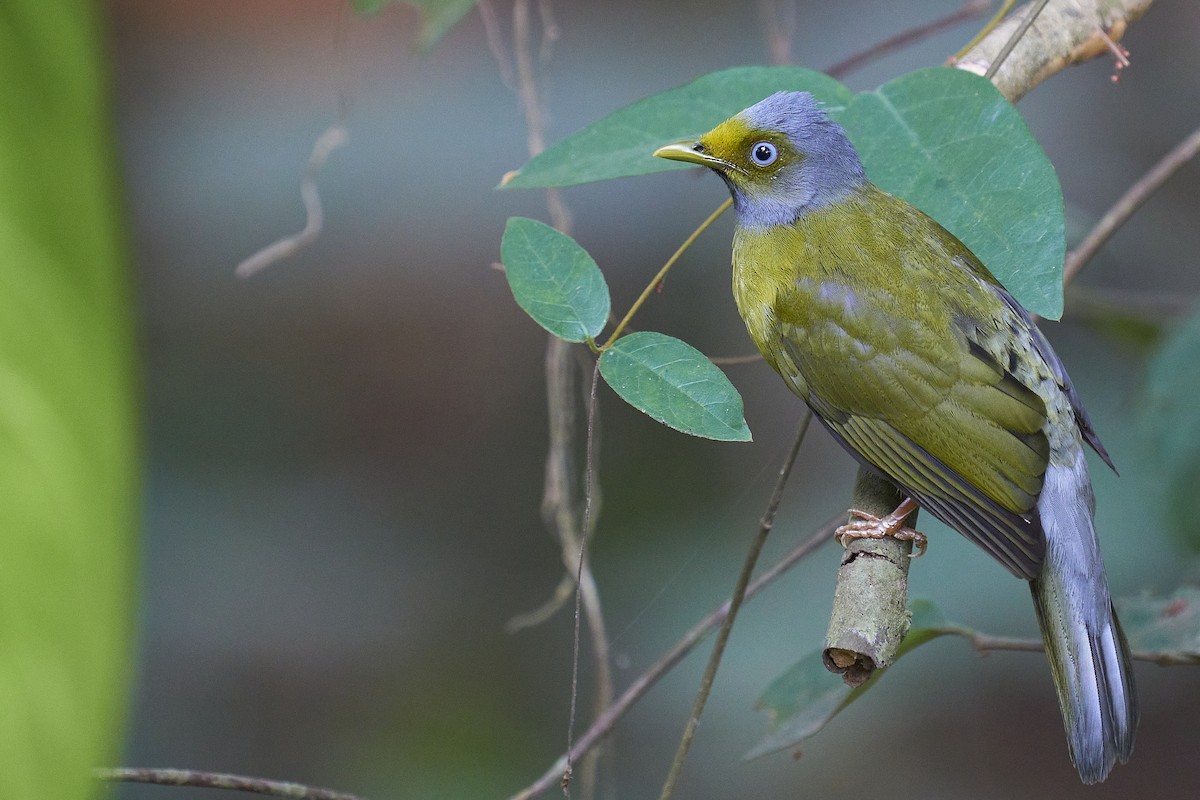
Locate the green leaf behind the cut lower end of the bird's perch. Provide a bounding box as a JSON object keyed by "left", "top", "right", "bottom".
{"left": 745, "top": 600, "right": 972, "bottom": 759}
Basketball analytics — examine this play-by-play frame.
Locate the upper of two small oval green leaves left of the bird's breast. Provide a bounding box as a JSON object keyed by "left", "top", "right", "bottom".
{"left": 500, "top": 217, "right": 611, "bottom": 342}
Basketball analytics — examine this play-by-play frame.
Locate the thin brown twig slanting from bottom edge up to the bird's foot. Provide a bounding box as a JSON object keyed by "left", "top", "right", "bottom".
{"left": 511, "top": 512, "right": 846, "bottom": 800}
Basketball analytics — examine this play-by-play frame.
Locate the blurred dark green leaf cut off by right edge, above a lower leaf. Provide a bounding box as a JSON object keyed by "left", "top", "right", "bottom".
{"left": 1136, "top": 313, "right": 1200, "bottom": 551}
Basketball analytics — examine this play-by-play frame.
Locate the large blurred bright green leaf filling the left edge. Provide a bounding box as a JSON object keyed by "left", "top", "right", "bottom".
{"left": 0, "top": 0, "right": 138, "bottom": 800}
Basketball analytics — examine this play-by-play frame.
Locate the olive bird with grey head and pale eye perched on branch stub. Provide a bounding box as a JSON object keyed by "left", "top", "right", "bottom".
{"left": 654, "top": 91, "right": 1139, "bottom": 783}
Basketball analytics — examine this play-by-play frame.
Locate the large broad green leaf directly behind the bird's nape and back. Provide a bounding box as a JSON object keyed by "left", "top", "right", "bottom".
{"left": 834, "top": 67, "right": 1066, "bottom": 319}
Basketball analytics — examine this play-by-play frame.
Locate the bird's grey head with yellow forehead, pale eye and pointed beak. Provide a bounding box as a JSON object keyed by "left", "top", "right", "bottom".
{"left": 654, "top": 91, "right": 866, "bottom": 227}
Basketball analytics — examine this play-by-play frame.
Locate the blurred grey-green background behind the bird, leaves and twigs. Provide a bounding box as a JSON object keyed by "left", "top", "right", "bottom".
{"left": 91, "top": 0, "right": 1200, "bottom": 800}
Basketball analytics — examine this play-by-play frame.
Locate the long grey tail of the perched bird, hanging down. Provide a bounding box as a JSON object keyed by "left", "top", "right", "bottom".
{"left": 1030, "top": 515, "right": 1138, "bottom": 783}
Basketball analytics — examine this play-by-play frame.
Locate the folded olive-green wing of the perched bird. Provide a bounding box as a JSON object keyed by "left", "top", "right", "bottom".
{"left": 773, "top": 281, "right": 1050, "bottom": 579}
